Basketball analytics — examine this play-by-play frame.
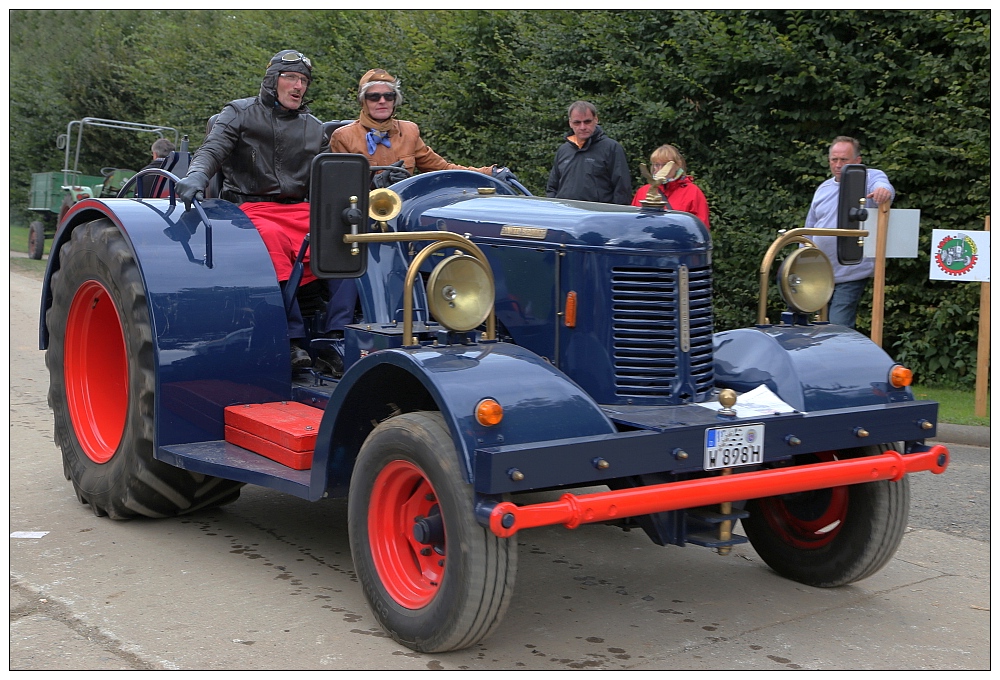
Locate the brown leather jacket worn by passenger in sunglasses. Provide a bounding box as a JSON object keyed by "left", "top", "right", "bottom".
{"left": 330, "top": 120, "right": 493, "bottom": 175}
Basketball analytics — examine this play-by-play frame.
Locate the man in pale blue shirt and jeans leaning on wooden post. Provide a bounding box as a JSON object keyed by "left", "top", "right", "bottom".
{"left": 805, "top": 137, "right": 896, "bottom": 328}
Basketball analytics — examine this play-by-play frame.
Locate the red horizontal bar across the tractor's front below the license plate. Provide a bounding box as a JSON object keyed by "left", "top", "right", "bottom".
{"left": 489, "top": 445, "right": 949, "bottom": 538}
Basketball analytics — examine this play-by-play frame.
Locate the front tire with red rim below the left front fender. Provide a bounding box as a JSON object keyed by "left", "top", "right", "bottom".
{"left": 348, "top": 413, "right": 517, "bottom": 652}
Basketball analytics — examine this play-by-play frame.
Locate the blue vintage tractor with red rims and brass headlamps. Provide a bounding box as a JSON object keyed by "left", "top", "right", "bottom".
{"left": 40, "top": 154, "right": 948, "bottom": 652}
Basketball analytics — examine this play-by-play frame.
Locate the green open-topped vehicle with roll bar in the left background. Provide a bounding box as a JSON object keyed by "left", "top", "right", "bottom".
{"left": 28, "top": 118, "right": 177, "bottom": 260}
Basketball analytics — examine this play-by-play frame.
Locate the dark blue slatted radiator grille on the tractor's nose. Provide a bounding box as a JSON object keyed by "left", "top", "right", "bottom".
{"left": 611, "top": 267, "right": 714, "bottom": 401}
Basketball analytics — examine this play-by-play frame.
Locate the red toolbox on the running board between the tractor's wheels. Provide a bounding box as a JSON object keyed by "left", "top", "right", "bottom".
{"left": 225, "top": 401, "right": 323, "bottom": 470}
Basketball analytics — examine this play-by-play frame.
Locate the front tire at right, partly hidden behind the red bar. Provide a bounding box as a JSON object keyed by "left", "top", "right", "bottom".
{"left": 742, "top": 445, "right": 910, "bottom": 588}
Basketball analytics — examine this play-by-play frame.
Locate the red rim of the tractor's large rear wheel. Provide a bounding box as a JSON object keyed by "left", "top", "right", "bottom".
{"left": 63, "top": 281, "right": 128, "bottom": 463}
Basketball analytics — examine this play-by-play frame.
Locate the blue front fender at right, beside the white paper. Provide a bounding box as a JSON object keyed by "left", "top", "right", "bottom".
{"left": 714, "top": 324, "right": 913, "bottom": 412}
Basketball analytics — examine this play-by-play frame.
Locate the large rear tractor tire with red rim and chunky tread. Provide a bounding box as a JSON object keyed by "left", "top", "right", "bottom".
{"left": 45, "top": 219, "right": 243, "bottom": 519}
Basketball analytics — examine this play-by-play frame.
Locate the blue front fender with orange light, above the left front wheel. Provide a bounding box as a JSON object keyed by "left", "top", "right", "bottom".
{"left": 310, "top": 342, "right": 616, "bottom": 496}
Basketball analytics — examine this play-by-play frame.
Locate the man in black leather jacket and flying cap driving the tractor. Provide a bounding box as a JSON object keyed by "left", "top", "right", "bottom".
{"left": 176, "top": 50, "right": 355, "bottom": 368}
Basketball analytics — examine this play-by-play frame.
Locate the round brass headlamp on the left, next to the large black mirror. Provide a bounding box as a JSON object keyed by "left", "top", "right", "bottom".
{"left": 427, "top": 253, "right": 494, "bottom": 331}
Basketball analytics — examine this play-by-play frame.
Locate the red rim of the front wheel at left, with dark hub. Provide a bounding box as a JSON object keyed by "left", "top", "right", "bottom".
{"left": 368, "top": 460, "right": 445, "bottom": 609}
